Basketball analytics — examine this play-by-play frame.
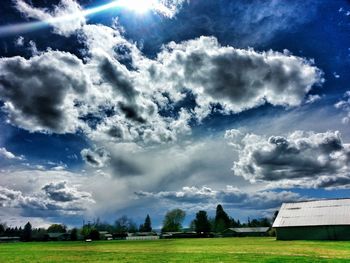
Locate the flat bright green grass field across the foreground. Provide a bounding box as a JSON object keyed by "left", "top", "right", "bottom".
{"left": 0, "top": 238, "right": 350, "bottom": 263}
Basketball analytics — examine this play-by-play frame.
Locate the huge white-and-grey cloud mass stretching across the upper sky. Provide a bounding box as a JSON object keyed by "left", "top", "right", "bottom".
{"left": 0, "top": 22, "right": 322, "bottom": 145}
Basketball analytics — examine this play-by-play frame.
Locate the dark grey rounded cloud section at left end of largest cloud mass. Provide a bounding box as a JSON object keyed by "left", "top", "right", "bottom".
{"left": 0, "top": 51, "right": 88, "bottom": 133}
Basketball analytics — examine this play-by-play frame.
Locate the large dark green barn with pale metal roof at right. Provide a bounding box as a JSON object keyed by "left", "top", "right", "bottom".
{"left": 273, "top": 199, "right": 350, "bottom": 240}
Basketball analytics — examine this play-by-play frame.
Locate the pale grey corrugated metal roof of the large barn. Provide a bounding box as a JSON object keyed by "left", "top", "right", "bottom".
{"left": 273, "top": 199, "right": 350, "bottom": 227}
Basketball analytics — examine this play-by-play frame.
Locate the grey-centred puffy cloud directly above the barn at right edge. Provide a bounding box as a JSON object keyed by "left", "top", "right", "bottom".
{"left": 226, "top": 130, "right": 350, "bottom": 187}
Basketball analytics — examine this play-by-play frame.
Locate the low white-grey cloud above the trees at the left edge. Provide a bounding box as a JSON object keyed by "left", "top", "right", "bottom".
{"left": 0, "top": 182, "right": 95, "bottom": 216}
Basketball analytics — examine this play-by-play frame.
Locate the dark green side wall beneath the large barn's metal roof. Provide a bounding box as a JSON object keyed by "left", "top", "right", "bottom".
{"left": 276, "top": 226, "right": 350, "bottom": 240}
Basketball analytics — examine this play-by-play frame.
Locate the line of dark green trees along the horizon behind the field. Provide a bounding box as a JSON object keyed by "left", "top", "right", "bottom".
{"left": 0, "top": 204, "right": 277, "bottom": 241}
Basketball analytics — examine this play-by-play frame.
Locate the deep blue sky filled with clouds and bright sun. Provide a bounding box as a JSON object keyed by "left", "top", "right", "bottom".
{"left": 0, "top": 0, "right": 350, "bottom": 230}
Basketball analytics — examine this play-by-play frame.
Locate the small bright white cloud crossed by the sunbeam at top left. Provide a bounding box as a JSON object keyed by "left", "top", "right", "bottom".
{"left": 13, "top": 0, "right": 86, "bottom": 37}
